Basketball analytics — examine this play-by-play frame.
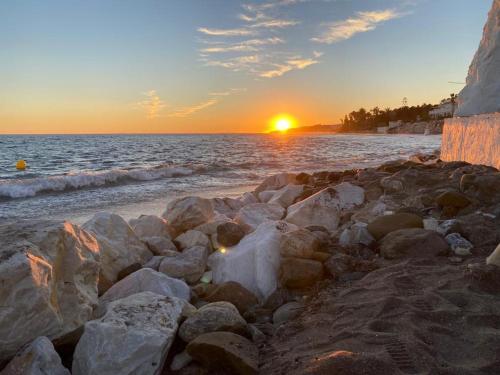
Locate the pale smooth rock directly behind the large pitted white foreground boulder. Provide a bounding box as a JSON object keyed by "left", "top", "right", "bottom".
{"left": 95, "top": 268, "right": 191, "bottom": 317}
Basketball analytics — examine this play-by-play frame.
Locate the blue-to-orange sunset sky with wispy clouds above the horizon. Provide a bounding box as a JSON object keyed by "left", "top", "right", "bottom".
{"left": 0, "top": 0, "right": 492, "bottom": 134}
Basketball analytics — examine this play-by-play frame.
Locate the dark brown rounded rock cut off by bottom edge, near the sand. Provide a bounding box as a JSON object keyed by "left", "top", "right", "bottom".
{"left": 187, "top": 332, "right": 259, "bottom": 375}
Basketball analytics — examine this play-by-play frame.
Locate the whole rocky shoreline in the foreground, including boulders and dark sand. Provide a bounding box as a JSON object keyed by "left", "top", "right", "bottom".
{"left": 0, "top": 155, "right": 500, "bottom": 375}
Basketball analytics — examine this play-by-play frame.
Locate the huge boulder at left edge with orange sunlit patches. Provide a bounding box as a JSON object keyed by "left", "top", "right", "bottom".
{"left": 0, "top": 220, "right": 99, "bottom": 361}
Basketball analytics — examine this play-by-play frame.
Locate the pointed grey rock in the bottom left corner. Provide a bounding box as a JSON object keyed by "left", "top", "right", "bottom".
{"left": 0, "top": 336, "right": 71, "bottom": 375}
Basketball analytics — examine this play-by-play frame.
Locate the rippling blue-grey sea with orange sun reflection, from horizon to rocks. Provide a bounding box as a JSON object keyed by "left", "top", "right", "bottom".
{"left": 0, "top": 134, "right": 441, "bottom": 222}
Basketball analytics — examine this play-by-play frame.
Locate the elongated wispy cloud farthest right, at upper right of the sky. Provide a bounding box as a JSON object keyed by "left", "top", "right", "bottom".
{"left": 311, "top": 9, "right": 405, "bottom": 44}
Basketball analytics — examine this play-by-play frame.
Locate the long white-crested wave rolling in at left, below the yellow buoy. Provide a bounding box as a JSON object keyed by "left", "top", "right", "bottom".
{"left": 0, "top": 166, "right": 195, "bottom": 199}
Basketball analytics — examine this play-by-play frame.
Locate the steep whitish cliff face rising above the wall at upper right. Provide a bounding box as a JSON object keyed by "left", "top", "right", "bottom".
{"left": 456, "top": 0, "right": 500, "bottom": 116}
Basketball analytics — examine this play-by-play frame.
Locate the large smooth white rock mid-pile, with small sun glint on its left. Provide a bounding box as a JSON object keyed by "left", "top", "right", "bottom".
{"left": 208, "top": 221, "right": 297, "bottom": 300}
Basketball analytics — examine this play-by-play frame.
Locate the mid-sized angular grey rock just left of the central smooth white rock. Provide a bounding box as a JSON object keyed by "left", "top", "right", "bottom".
{"left": 158, "top": 246, "right": 208, "bottom": 284}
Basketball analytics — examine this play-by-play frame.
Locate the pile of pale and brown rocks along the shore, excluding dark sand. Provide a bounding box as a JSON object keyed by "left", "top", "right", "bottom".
{"left": 0, "top": 154, "right": 500, "bottom": 374}
